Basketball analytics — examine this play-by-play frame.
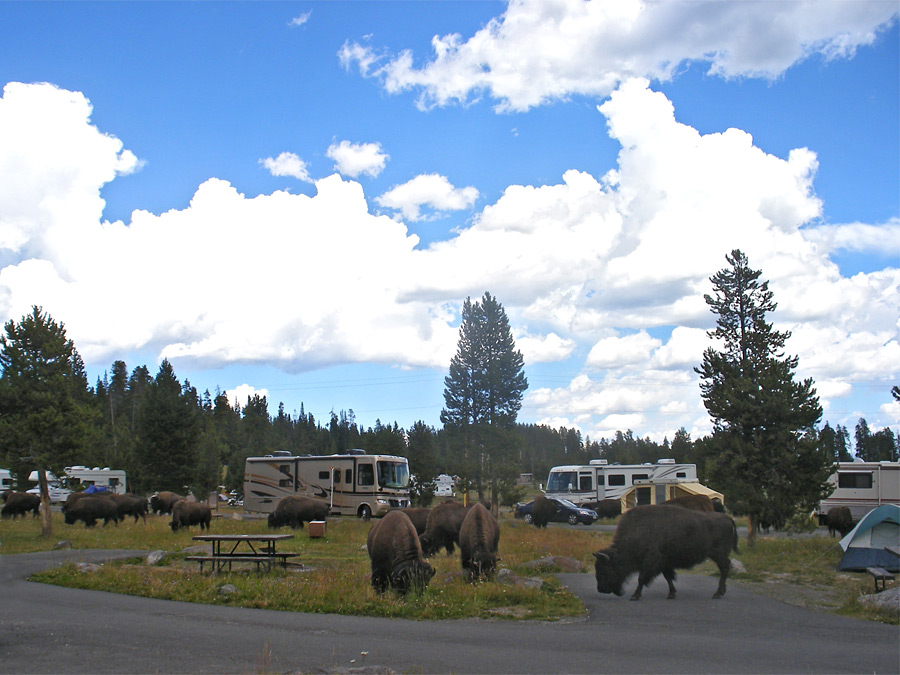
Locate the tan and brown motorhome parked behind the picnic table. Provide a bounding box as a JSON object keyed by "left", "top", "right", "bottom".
{"left": 244, "top": 450, "right": 409, "bottom": 518}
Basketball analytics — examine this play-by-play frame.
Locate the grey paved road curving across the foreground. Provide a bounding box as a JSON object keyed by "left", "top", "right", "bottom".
{"left": 0, "top": 551, "right": 900, "bottom": 673}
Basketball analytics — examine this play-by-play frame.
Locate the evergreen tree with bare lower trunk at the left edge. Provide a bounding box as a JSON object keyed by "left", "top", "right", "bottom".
{"left": 0, "top": 306, "right": 91, "bottom": 536}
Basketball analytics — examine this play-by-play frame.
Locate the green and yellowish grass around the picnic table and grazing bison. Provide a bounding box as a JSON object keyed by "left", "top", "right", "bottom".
{"left": 0, "top": 509, "right": 900, "bottom": 623}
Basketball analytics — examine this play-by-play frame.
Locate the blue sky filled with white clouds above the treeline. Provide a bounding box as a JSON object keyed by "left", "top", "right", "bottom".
{"left": 0, "top": 0, "right": 900, "bottom": 440}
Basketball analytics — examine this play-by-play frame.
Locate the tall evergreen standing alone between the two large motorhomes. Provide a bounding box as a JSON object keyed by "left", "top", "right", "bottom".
{"left": 441, "top": 293, "right": 528, "bottom": 504}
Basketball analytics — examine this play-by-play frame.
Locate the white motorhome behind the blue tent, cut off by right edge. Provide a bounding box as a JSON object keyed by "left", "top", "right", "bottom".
{"left": 816, "top": 462, "right": 900, "bottom": 521}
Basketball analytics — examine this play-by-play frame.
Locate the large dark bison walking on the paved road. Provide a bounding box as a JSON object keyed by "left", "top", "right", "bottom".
{"left": 594, "top": 504, "right": 738, "bottom": 600}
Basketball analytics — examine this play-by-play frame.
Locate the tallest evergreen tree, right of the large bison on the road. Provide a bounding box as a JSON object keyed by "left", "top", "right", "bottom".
{"left": 696, "top": 250, "right": 834, "bottom": 544}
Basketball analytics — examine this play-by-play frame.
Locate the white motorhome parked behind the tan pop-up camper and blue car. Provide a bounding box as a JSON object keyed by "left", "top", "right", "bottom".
{"left": 544, "top": 459, "right": 697, "bottom": 506}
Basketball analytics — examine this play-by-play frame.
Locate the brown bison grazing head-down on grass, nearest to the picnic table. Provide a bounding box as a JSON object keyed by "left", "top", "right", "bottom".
{"left": 366, "top": 510, "right": 434, "bottom": 595}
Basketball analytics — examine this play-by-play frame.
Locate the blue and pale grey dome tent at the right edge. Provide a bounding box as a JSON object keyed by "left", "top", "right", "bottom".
{"left": 838, "top": 504, "right": 900, "bottom": 572}
